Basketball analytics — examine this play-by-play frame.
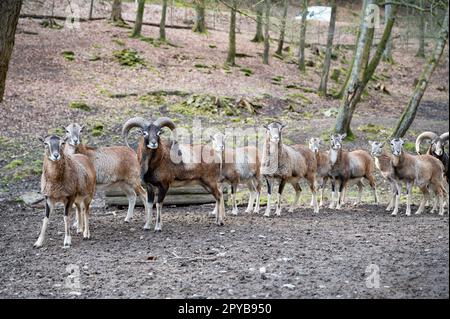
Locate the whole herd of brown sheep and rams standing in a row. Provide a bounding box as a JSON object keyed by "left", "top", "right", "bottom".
{"left": 34, "top": 117, "right": 449, "bottom": 247}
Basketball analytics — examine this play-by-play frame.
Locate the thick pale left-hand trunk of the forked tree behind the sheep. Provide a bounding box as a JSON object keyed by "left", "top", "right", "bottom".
{"left": 334, "top": 0, "right": 374, "bottom": 136}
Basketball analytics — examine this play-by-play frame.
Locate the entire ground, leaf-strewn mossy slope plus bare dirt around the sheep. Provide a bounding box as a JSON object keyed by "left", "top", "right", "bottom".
{"left": 0, "top": 1, "right": 449, "bottom": 298}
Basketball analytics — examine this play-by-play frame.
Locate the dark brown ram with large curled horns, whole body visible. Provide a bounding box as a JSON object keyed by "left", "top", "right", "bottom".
{"left": 122, "top": 117, "right": 225, "bottom": 231}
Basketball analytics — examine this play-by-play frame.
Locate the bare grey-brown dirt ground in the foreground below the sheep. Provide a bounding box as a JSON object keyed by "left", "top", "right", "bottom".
{"left": 0, "top": 205, "right": 449, "bottom": 298}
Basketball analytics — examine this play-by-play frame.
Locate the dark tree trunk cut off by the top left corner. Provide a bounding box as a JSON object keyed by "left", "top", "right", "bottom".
{"left": 0, "top": 0, "right": 22, "bottom": 102}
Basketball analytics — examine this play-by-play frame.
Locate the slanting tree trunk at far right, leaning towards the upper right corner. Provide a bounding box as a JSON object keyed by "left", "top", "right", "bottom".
{"left": 392, "top": 5, "right": 448, "bottom": 137}
